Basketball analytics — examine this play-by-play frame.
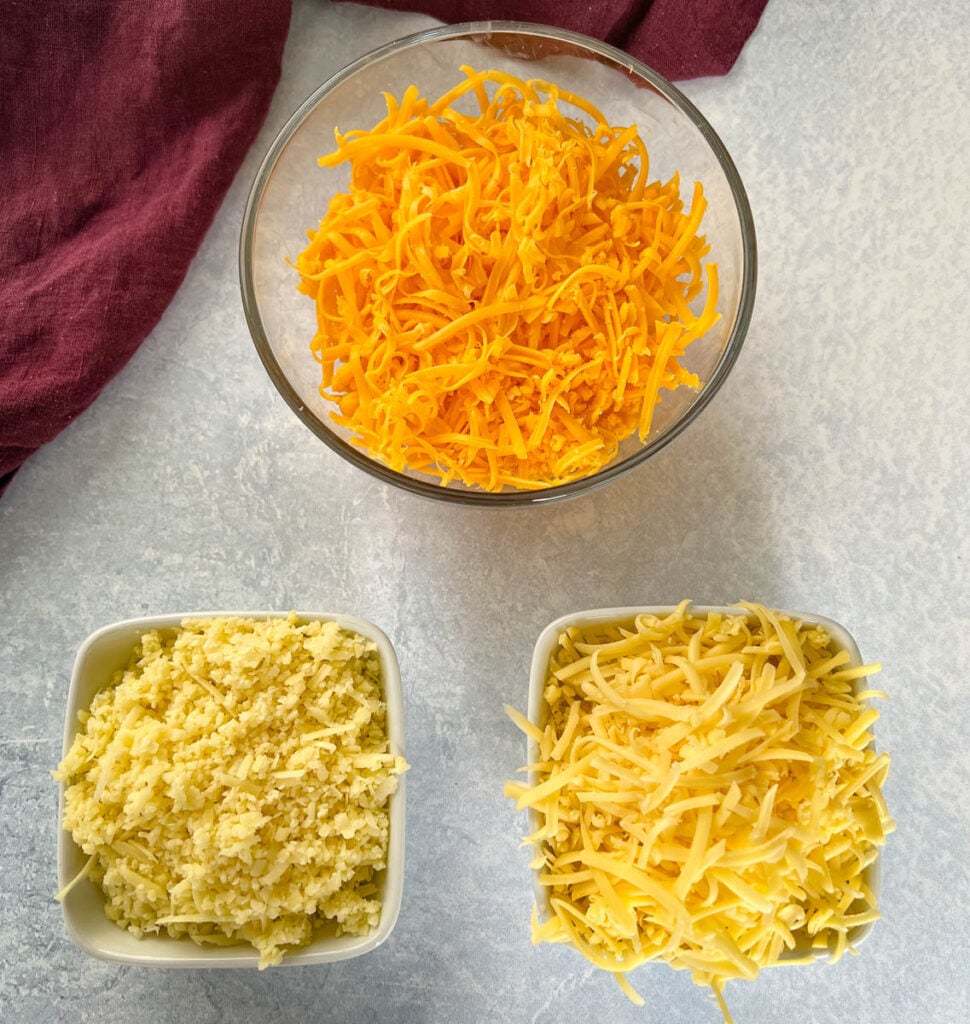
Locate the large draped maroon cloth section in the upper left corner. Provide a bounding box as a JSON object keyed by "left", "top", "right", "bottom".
{"left": 0, "top": 0, "right": 290, "bottom": 492}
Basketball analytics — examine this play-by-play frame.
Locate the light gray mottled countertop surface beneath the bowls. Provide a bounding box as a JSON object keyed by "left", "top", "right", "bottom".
{"left": 0, "top": 0, "right": 970, "bottom": 1024}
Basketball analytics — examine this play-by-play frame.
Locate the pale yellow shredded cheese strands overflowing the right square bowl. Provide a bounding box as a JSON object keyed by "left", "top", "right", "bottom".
{"left": 506, "top": 601, "right": 894, "bottom": 1021}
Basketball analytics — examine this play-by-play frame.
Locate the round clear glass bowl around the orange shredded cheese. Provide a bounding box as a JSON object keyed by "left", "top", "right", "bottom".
{"left": 240, "top": 22, "right": 756, "bottom": 506}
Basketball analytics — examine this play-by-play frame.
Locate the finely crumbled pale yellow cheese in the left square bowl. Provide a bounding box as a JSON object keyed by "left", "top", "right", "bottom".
{"left": 54, "top": 614, "right": 408, "bottom": 968}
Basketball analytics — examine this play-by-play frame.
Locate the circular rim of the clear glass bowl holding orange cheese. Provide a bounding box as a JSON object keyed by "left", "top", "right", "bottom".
{"left": 239, "top": 19, "right": 758, "bottom": 508}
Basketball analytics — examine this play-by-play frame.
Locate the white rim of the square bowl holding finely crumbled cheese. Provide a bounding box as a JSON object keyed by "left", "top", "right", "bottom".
{"left": 56, "top": 609, "right": 407, "bottom": 969}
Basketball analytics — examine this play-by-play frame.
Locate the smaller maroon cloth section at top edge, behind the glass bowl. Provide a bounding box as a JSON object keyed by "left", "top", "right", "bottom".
{"left": 338, "top": 0, "right": 768, "bottom": 81}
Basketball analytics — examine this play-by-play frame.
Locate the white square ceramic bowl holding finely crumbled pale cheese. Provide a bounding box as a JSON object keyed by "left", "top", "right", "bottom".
{"left": 57, "top": 611, "right": 405, "bottom": 968}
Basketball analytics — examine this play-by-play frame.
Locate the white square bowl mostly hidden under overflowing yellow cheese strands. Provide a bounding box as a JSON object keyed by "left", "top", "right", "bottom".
{"left": 528, "top": 604, "right": 880, "bottom": 961}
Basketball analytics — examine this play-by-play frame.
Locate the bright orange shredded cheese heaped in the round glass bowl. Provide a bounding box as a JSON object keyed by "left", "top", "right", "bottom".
{"left": 296, "top": 67, "right": 719, "bottom": 492}
